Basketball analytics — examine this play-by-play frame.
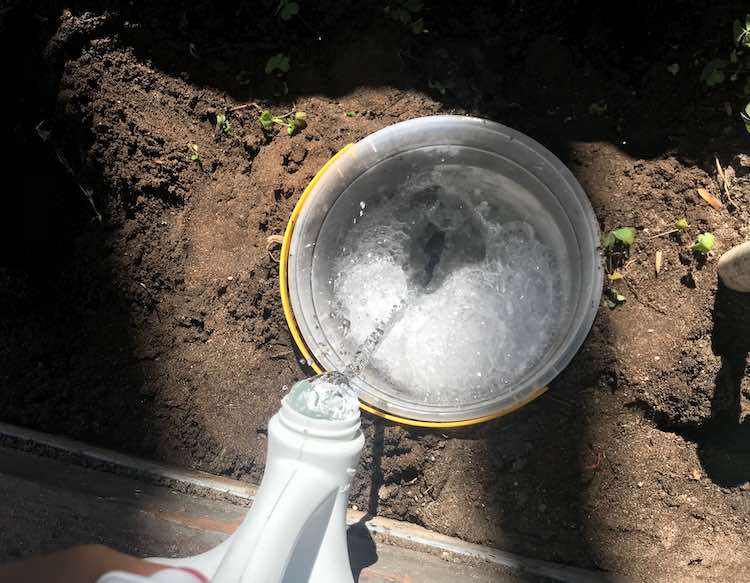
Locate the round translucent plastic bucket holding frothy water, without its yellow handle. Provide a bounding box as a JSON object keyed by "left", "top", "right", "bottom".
{"left": 288, "top": 116, "right": 601, "bottom": 421}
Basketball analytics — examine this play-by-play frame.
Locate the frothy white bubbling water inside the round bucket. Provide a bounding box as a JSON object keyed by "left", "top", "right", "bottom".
{"left": 332, "top": 185, "right": 561, "bottom": 405}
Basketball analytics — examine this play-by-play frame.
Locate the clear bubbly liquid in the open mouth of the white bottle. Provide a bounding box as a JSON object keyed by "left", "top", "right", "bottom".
{"left": 286, "top": 372, "right": 359, "bottom": 421}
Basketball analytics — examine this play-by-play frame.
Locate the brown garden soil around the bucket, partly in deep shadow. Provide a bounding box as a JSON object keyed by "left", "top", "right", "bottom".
{"left": 0, "top": 0, "right": 750, "bottom": 581}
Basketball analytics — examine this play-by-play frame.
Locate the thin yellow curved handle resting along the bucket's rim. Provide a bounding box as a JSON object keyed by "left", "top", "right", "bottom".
{"left": 279, "top": 144, "right": 547, "bottom": 429}
